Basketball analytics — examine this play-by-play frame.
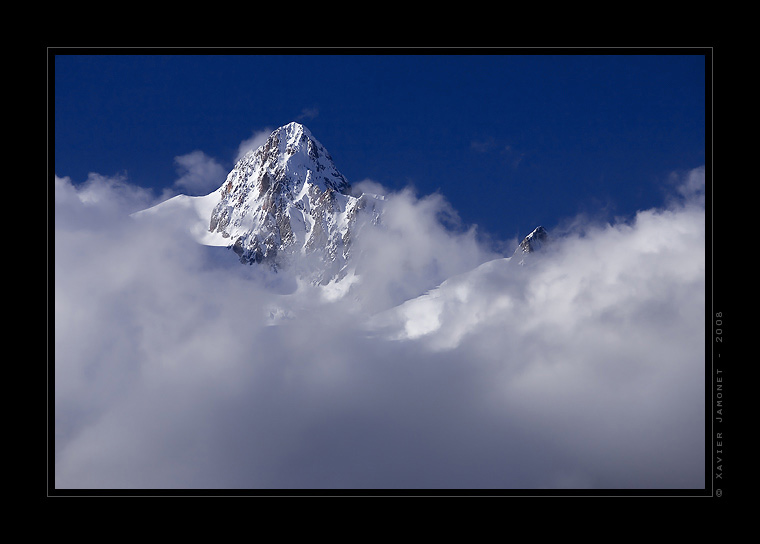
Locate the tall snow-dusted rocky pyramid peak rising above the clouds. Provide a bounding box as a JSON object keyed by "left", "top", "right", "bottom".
{"left": 209, "top": 123, "right": 382, "bottom": 283}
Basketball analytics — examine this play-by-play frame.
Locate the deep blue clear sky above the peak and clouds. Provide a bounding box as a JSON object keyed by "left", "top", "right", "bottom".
{"left": 53, "top": 49, "right": 706, "bottom": 246}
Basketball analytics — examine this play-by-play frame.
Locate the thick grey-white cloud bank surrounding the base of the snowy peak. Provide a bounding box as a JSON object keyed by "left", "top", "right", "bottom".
{"left": 54, "top": 169, "right": 705, "bottom": 489}
